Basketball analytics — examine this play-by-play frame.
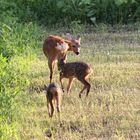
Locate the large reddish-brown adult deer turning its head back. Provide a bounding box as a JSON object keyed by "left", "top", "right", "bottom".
{"left": 43, "top": 34, "right": 81, "bottom": 83}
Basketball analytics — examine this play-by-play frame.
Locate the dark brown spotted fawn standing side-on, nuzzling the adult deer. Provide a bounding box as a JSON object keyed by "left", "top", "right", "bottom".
{"left": 58, "top": 59, "right": 93, "bottom": 98}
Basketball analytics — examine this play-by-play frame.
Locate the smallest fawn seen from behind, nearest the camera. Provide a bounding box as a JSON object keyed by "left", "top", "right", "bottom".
{"left": 45, "top": 83, "right": 62, "bottom": 118}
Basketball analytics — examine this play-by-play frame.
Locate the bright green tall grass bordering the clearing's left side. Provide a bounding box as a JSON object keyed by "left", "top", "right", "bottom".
{"left": 0, "top": 22, "right": 44, "bottom": 140}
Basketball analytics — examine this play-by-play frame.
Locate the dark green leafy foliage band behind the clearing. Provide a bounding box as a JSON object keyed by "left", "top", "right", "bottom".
{"left": 0, "top": 0, "right": 140, "bottom": 25}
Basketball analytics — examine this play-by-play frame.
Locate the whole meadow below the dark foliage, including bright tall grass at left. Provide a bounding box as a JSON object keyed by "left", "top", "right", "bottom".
{"left": 0, "top": 21, "right": 140, "bottom": 140}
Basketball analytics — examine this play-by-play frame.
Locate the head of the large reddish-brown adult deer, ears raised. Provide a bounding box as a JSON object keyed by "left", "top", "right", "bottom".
{"left": 66, "top": 33, "right": 81, "bottom": 55}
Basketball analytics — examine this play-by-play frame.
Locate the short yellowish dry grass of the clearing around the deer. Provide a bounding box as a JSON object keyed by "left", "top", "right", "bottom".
{"left": 19, "top": 32, "right": 140, "bottom": 140}
